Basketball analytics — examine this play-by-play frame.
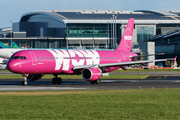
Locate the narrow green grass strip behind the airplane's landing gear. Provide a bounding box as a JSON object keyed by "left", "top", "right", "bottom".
{"left": 0, "top": 74, "right": 148, "bottom": 79}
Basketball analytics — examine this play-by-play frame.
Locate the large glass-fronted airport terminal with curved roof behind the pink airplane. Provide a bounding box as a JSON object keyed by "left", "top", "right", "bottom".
{"left": 0, "top": 10, "right": 180, "bottom": 65}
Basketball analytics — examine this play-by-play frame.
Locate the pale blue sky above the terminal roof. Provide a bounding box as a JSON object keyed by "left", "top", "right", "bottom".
{"left": 0, "top": 0, "right": 180, "bottom": 28}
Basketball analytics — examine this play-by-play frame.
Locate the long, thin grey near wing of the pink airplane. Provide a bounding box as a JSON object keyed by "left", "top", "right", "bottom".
{"left": 73, "top": 58, "right": 173, "bottom": 70}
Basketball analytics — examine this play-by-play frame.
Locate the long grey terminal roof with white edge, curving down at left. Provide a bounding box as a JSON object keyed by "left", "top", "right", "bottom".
{"left": 20, "top": 10, "right": 180, "bottom": 24}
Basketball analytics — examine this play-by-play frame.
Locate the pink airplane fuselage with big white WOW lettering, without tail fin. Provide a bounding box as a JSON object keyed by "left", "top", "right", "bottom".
{"left": 8, "top": 49, "right": 137, "bottom": 74}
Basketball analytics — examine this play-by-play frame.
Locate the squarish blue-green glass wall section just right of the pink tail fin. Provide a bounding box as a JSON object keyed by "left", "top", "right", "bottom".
{"left": 137, "top": 26, "right": 155, "bottom": 42}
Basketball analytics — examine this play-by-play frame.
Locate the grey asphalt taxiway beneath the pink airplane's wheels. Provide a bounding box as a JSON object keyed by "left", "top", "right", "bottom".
{"left": 0, "top": 71, "right": 180, "bottom": 91}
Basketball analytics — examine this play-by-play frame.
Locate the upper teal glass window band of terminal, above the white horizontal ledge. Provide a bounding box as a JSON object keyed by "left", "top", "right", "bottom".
{"left": 66, "top": 24, "right": 110, "bottom": 38}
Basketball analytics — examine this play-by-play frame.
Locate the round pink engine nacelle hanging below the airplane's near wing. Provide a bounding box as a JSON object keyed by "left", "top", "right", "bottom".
{"left": 82, "top": 68, "right": 102, "bottom": 81}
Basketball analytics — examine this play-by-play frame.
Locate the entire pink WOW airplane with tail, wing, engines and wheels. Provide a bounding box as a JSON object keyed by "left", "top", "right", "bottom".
{"left": 7, "top": 18, "right": 167, "bottom": 85}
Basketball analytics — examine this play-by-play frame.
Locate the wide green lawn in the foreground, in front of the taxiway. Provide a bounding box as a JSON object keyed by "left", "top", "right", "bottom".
{"left": 0, "top": 88, "right": 180, "bottom": 120}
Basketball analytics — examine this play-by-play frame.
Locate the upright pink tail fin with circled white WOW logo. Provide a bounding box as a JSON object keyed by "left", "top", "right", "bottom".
{"left": 116, "top": 18, "right": 134, "bottom": 52}
